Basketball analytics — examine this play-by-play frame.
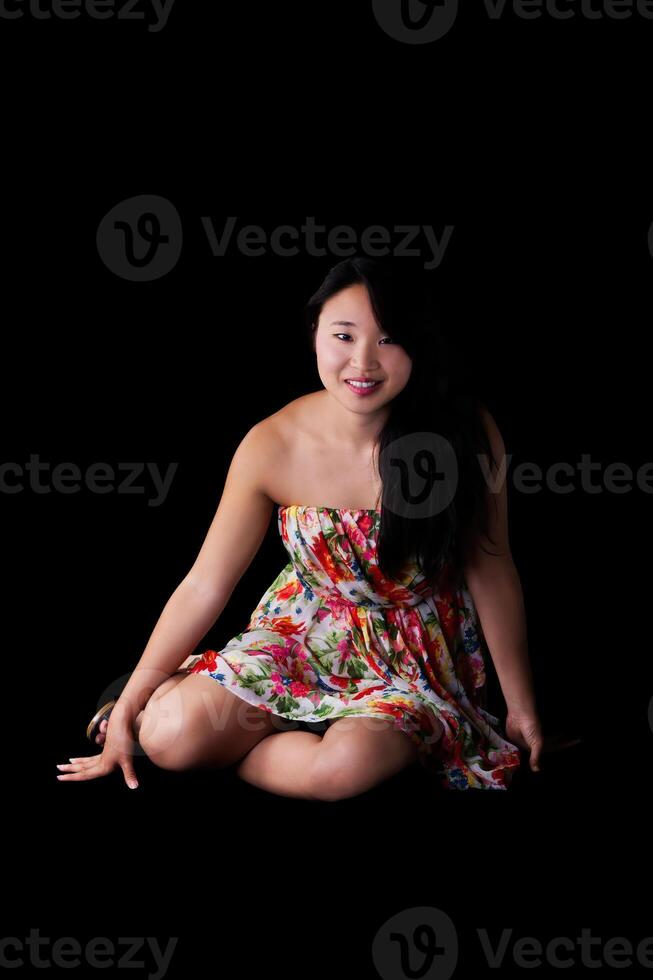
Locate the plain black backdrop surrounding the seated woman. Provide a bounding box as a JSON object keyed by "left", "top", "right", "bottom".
{"left": 0, "top": 0, "right": 653, "bottom": 977}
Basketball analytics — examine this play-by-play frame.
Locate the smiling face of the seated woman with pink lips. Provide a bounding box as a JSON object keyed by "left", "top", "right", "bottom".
{"left": 315, "top": 283, "right": 412, "bottom": 413}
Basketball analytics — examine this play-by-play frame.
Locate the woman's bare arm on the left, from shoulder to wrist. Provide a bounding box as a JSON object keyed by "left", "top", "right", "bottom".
{"left": 112, "top": 419, "right": 281, "bottom": 720}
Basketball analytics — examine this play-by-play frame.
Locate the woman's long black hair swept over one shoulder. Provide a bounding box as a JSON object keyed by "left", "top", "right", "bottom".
{"left": 304, "top": 256, "right": 497, "bottom": 584}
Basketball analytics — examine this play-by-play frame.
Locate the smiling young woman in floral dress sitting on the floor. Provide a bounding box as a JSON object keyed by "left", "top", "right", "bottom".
{"left": 60, "top": 257, "right": 543, "bottom": 800}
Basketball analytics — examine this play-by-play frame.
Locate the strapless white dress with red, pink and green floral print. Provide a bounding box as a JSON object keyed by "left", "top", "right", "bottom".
{"left": 179, "top": 504, "right": 520, "bottom": 790}
